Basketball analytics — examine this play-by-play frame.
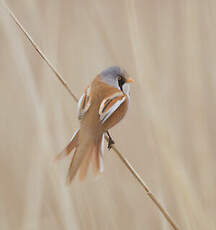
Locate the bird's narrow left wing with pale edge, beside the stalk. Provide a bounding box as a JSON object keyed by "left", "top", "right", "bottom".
{"left": 78, "top": 86, "right": 91, "bottom": 120}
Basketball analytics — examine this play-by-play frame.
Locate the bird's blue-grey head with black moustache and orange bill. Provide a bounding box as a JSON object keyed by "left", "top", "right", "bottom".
{"left": 100, "top": 66, "right": 133, "bottom": 94}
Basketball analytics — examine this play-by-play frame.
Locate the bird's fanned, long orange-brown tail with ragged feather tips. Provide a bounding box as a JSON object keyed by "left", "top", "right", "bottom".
{"left": 56, "top": 130, "right": 104, "bottom": 184}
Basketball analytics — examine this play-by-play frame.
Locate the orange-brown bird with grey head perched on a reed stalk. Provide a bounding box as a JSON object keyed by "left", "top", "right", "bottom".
{"left": 56, "top": 66, "right": 134, "bottom": 184}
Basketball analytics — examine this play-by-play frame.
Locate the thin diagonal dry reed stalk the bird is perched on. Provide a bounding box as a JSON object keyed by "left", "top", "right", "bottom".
{"left": 2, "top": 1, "right": 179, "bottom": 230}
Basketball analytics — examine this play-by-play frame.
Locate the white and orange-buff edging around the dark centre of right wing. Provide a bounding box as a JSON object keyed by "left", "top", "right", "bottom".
{"left": 99, "top": 92, "right": 126, "bottom": 123}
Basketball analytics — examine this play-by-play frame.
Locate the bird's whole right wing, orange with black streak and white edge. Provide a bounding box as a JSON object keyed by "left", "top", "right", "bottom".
{"left": 99, "top": 92, "right": 127, "bottom": 123}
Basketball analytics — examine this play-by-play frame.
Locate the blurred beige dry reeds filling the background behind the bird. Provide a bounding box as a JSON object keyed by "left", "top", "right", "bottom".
{"left": 0, "top": 0, "right": 216, "bottom": 230}
